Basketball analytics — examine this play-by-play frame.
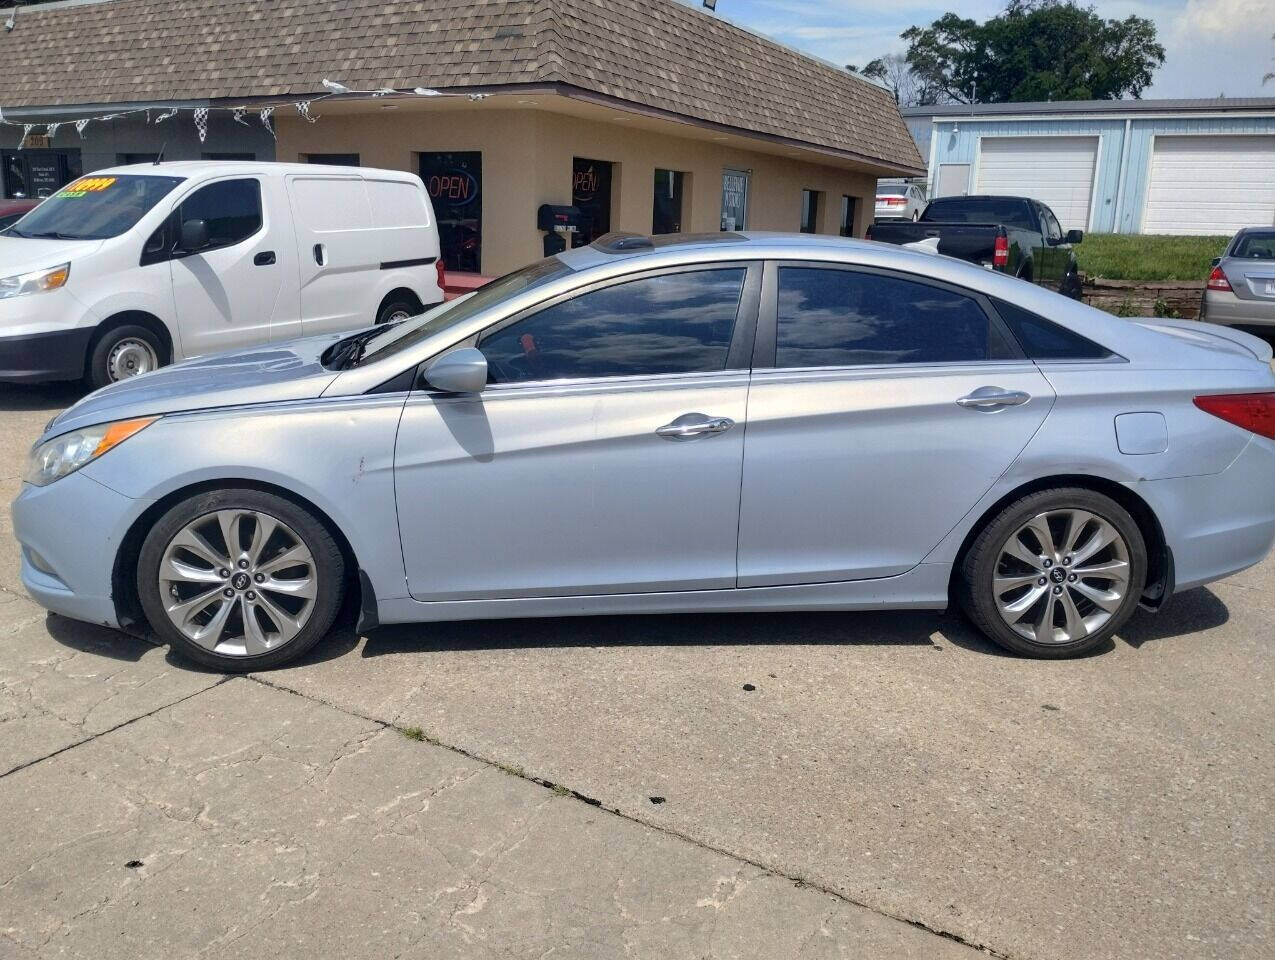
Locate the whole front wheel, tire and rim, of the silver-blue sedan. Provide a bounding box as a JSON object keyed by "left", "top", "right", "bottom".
{"left": 138, "top": 490, "right": 344, "bottom": 672}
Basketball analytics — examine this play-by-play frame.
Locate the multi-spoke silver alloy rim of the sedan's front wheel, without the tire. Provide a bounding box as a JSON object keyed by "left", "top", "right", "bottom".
{"left": 159, "top": 509, "right": 319, "bottom": 657}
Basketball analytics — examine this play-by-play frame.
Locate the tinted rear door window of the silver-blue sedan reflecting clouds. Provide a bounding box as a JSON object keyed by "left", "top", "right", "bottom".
{"left": 775, "top": 266, "right": 1012, "bottom": 367}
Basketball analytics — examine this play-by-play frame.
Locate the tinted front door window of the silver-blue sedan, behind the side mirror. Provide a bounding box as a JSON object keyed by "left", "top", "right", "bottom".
{"left": 478, "top": 268, "right": 745, "bottom": 384}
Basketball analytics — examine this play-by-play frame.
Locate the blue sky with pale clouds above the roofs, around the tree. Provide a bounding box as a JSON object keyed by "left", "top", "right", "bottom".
{"left": 683, "top": 0, "right": 1275, "bottom": 97}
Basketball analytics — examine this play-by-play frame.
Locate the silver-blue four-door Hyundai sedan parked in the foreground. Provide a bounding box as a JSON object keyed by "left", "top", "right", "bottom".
{"left": 14, "top": 233, "right": 1275, "bottom": 671}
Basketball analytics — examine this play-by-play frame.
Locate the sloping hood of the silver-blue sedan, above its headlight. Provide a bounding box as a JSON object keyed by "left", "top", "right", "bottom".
{"left": 45, "top": 333, "right": 349, "bottom": 436}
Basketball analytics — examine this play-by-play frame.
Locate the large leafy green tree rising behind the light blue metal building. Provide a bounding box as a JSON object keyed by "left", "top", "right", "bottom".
{"left": 887, "top": 0, "right": 1164, "bottom": 103}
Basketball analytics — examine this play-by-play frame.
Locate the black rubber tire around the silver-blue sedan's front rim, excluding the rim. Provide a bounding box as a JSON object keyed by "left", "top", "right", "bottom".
{"left": 136, "top": 488, "right": 346, "bottom": 673}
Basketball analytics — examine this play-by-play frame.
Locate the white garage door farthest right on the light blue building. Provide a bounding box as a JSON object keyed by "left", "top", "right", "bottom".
{"left": 1142, "top": 136, "right": 1275, "bottom": 235}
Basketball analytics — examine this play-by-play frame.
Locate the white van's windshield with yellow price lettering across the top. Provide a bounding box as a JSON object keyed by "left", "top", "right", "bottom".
{"left": 5, "top": 173, "right": 182, "bottom": 240}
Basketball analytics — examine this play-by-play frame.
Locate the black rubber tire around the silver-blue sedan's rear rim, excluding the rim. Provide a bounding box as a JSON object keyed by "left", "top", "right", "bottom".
{"left": 956, "top": 487, "right": 1146, "bottom": 659}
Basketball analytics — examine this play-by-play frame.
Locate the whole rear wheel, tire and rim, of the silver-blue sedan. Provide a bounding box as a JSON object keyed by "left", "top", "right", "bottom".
{"left": 959, "top": 487, "right": 1146, "bottom": 659}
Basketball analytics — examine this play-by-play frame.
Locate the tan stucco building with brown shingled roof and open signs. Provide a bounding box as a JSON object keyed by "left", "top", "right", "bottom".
{"left": 0, "top": 0, "right": 923, "bottom": 274}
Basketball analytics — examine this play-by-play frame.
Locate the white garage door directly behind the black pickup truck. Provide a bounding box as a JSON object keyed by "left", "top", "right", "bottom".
{"left": 977, "top": 136, "right": 1098, "bottom": 229}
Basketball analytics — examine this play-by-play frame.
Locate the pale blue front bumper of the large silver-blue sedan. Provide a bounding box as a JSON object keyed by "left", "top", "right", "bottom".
{"left": 13, "top": 472, "right": 150, "bottom": 627}
